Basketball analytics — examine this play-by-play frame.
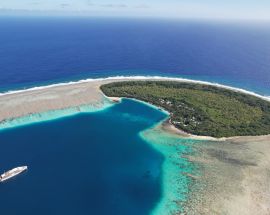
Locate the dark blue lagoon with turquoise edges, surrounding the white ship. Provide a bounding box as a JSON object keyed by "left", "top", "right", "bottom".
{"left": 0, "top": 99, "right": 197, "bottom": 215}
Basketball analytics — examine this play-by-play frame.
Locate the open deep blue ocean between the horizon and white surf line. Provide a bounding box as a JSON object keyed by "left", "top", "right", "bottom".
{"left": 0, "top": 17, "right": 270, "bottom": 95}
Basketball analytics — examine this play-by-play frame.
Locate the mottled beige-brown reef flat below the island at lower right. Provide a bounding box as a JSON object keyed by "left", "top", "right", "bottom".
{"left": 180, "top": 135, "right": 270, "bottom": 215}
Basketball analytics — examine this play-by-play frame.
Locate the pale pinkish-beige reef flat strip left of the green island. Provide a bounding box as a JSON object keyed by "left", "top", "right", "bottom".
{"left": 0, "top": 80, "right": 103, "bottom": 122}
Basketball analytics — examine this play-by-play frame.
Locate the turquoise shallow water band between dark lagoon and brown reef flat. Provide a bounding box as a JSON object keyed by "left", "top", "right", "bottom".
{"left": 140, "top": 126, "right": 199, "bottom": 215}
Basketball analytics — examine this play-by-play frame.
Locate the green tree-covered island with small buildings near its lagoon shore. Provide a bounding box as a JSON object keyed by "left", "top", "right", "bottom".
{"left": 101, "top": 81, "right": 270, "bottom": 137}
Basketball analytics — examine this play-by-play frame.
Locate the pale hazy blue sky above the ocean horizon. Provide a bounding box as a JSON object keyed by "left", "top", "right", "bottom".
{"left": 0, "top": 0, "right": 270, "bottom": 20}
